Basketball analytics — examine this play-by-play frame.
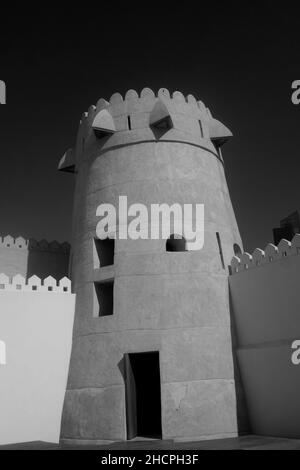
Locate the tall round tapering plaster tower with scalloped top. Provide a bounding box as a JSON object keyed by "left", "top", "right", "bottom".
{"left": 60, "top": 88, "right": 241, "bottom": 443}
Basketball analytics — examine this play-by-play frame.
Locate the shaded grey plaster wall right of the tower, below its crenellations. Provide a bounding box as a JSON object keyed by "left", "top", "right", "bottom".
{"left": 229, "top": 254, "right": 300, "bottom": 438}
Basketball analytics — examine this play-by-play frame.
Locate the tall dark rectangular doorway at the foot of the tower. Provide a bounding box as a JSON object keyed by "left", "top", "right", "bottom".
{"left": 125, "top": 351, "right": 162, "bottom": 439}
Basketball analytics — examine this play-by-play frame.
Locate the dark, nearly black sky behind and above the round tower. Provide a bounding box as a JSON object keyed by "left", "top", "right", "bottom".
{"left": 0, "top": 1, "right": 300, "bottom": 251}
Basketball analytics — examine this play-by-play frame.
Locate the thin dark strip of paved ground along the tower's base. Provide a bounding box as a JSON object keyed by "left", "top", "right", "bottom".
{"left": 0, "top": 435, "right": 300, "bottom": 451}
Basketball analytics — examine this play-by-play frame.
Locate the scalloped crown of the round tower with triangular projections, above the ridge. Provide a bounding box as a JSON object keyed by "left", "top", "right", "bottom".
{"left": 58, "top": 88, "right": 232, "bottom": 173}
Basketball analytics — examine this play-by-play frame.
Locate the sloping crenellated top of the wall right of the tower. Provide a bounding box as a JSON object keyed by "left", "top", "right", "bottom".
{"left": 231, "top": 233, "right": 300, "bottom": 275}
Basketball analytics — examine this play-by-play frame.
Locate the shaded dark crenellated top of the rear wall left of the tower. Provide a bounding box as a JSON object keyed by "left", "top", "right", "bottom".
{"left": 0, "top": 235, "right": 70, "bottom": 253}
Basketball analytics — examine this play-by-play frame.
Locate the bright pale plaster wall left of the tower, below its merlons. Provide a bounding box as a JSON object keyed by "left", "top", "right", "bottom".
{"left": 0, "top": 291, "right": 75, "bottom": 444}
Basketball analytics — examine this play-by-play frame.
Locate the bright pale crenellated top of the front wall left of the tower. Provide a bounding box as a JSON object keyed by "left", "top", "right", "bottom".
{"left": 0, "top": 273, "right": 71, "bottom": 294}
